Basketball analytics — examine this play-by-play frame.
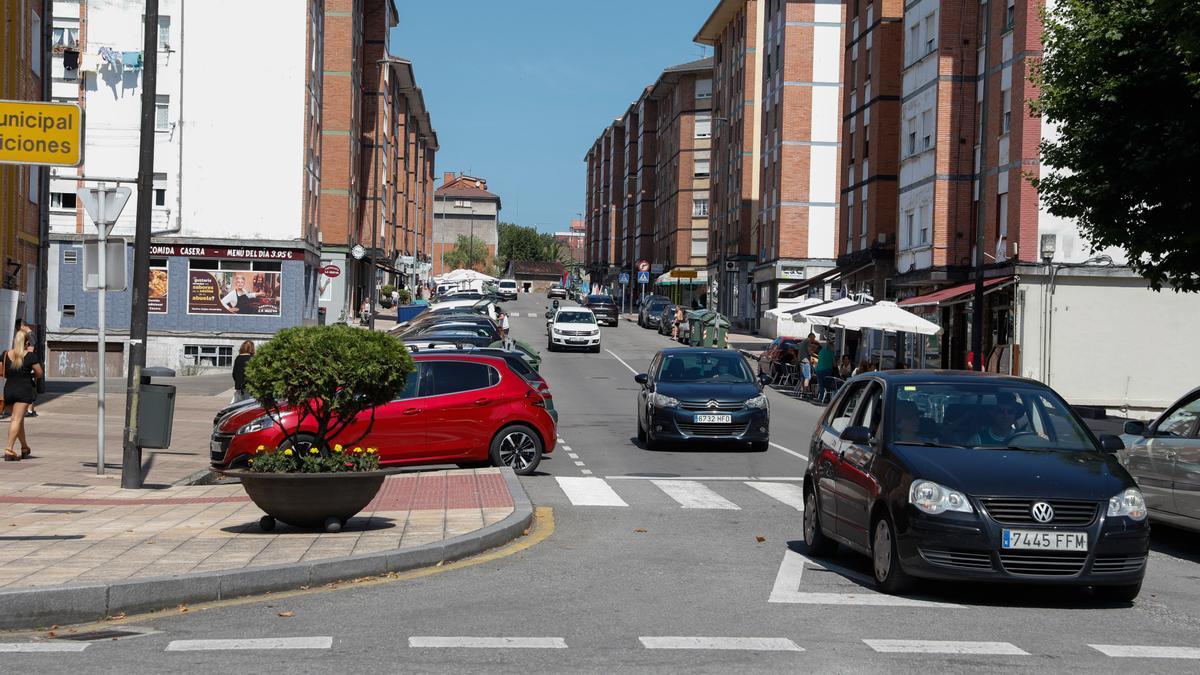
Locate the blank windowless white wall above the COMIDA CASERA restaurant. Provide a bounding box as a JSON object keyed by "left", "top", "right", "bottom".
{"left": 181, "top": 0, "right": 308, "bottom": 240}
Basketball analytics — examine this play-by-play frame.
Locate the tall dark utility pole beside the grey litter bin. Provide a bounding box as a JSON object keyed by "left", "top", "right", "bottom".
{"left": 121, "top": 0, "right": 158, "bottom": 488}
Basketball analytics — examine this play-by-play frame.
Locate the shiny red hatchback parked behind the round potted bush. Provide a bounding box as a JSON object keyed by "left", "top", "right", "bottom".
{"left": 210, "top": 352, "right": 557, "bottom": 476}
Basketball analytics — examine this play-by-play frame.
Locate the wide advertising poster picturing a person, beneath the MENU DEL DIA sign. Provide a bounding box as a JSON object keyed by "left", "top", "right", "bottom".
{"left": 187, "top": 269, "right": 282, "bottom": 316}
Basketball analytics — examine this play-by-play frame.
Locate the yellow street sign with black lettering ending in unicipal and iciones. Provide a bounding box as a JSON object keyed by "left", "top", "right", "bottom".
{"left": 0, "top": 101, "right": 83, "bottom": 167}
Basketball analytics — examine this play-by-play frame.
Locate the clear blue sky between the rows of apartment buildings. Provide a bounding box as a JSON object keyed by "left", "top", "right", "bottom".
{"left": 391, "top": 0, "right": 715, "bottom": 232}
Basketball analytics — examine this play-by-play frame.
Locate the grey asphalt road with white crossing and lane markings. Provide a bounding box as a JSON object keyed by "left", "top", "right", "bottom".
{"left": 7, "top": 297, "right": 1200, "bottom": 673}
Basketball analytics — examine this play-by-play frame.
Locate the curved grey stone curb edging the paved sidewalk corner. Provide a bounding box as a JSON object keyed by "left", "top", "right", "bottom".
{"left": 0, "top": 467, "right": 533, "bottom": 629}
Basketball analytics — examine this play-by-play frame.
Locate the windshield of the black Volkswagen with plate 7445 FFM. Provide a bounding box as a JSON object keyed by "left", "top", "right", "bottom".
{"left": 890, "top": 381, "right": 1097, "bottom": 452}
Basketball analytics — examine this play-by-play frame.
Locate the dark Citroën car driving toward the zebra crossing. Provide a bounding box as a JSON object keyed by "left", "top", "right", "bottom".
{"left": 635, "top": 347, "right": 770, "bottom": 452}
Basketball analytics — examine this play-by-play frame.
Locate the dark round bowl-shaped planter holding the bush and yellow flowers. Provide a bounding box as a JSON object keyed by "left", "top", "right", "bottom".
{"left": 221, "top": 468, "right": 395, "bottom": 532}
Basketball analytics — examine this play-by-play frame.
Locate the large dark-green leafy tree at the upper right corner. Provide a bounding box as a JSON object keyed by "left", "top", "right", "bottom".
{"left": 1032, "top": 0, "right": 1200, "bottom": 292}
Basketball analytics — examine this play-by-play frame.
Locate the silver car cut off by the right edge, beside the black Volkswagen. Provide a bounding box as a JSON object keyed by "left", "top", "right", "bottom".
{"left": 1120, "top": 388, "right": 1200, "bottom": 532}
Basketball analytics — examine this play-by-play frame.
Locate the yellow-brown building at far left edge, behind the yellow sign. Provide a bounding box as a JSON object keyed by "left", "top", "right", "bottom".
{"left": 0, "top": 0, "right": 48, "bottom": 345}
